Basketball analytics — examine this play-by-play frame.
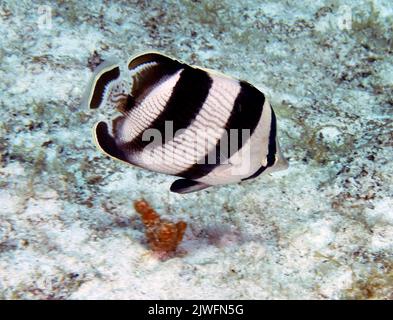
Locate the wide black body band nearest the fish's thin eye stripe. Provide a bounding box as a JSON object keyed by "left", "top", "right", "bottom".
{"left": 178, "top": 81, "right": 265, "bottom": 179}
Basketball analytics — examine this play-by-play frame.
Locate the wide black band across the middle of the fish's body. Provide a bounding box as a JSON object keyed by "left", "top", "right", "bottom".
{"left": 124, "top": 65, "right": 212, "bottom": 152}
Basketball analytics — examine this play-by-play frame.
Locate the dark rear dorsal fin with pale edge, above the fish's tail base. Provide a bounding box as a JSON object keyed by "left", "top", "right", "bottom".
{"left": 128, "top": 53, "right": 185, "bottom": 101}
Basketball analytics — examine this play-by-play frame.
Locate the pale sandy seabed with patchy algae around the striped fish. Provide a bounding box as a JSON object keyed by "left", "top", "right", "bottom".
{"left": 0, "top": 0, "right": 393, "bottom": 299}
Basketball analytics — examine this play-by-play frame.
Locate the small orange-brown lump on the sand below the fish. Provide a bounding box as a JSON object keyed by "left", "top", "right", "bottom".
{"left": 134, "top": 200, "right": 187, "bottom": 253}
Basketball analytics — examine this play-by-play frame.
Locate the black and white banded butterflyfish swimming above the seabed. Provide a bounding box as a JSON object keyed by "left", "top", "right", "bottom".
{"left": 85, "top": 52, "right": 288, "bottom": 193}
